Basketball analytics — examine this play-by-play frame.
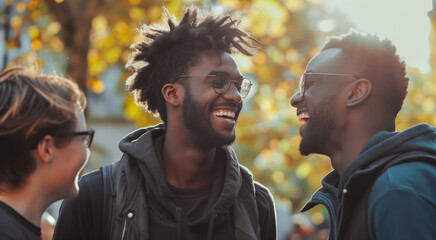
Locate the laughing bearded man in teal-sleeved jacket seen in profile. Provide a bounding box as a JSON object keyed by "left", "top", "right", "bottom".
{"left": 291, "top": 31, "right": 436, "bottom": 240}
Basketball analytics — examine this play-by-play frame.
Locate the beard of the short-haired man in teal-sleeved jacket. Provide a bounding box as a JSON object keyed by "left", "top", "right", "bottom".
{"left": 300, "top": 95, "right": 337, "bottom": 156}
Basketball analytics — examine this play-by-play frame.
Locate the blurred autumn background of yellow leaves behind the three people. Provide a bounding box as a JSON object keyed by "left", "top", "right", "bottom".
{"left": 0, "top": 0, "right": 436, "bottom": 240}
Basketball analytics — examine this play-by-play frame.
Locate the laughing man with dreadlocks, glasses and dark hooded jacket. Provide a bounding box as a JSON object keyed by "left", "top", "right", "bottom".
{"left": 55, "top": 8, "right": 276, "bottom": 240}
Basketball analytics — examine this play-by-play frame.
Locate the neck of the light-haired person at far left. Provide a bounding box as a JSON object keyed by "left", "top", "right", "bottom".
{"left": 0, "top": 175, "right": 50, "bottom": 226}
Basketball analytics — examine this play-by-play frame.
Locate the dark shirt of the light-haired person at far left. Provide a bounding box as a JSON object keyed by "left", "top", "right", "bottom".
{"left": 0, "top": 201, "right": 41, "bottom": 240}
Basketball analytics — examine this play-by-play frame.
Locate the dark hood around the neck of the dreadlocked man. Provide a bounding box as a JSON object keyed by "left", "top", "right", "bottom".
{"left": 119, "top": 124, "right": 242, "bottom": 227}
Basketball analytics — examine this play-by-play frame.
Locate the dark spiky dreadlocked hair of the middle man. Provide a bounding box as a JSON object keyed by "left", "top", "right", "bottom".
{"left": 126, "top": 8, "right": 258, "bottom": 123}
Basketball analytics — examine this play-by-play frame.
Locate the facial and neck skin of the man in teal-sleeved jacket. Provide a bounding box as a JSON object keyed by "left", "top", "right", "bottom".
{"left": 290, "top": 48, "right": 395, "bottom": 175}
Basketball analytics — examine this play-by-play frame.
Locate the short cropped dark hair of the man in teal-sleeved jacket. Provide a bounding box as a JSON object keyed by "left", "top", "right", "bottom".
{"left": 321, "top": 30, "right": 409, "bottom": 116}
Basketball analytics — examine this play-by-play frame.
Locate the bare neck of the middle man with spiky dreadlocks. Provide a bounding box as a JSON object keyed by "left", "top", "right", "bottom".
{"left": 161, "top": 129, "right": 216, "bottom": 189}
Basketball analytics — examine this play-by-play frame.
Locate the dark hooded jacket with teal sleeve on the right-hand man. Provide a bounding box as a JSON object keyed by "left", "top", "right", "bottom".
{"left": 302, "top": 124, "right": 436, "bottom": 240}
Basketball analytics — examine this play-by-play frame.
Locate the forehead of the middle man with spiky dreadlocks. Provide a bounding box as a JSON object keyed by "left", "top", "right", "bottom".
{"left": 189, "top": 50, "right": 241, "bottom": 77}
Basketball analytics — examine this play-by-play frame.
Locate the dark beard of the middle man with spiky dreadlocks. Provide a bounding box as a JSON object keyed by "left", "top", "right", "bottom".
{"left": 182, "top": 87, "right": 236, "bottom": 148}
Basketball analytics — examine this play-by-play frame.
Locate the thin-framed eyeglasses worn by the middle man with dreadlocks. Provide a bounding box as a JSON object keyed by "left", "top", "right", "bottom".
{"left": 174, "top": 74, "right": 253, "bottom": 98}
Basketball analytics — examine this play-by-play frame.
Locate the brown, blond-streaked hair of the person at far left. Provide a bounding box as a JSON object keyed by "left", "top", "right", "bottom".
{"left": 0, "top": 67, "right": 86, "bottom": 191}
